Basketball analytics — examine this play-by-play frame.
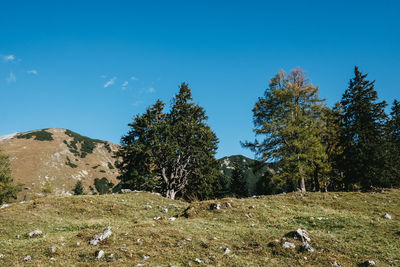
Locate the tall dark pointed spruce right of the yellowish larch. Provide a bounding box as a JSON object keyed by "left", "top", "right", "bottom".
{"left": 338, "top": 66, "right": 387, "bottom": 190}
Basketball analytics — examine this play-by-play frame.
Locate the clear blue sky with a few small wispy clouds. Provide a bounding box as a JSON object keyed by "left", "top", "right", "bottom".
{"left": 0, "top": 0, "right": 400, "bottom": 157}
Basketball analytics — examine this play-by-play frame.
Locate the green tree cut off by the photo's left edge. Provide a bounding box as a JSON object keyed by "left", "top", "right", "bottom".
{"left": 0, "top": 150, "right": 21, "bottom": 204}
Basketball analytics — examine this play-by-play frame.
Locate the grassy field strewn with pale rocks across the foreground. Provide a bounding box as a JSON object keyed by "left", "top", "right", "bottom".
{"left": 0, "top": 190, "right": 400, "bottom": 266}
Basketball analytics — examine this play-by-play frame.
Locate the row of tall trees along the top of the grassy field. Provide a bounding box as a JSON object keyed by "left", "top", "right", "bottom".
{"left": 116, "top": 67, "right": 400, "bottom": 200}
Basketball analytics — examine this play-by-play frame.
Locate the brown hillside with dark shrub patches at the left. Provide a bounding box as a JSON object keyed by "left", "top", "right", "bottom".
{"left": 0, "top": 129, "right": 118, "bottom": 199}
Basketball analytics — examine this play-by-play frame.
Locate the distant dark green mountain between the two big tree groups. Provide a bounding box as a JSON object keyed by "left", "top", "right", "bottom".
{"left": 219, "top": 155, "right": 271, "bottom": 196}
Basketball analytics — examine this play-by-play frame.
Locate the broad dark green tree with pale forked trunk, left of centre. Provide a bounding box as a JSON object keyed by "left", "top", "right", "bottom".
{"left": 116, "top": 83, "right": 222, "bottom": 199}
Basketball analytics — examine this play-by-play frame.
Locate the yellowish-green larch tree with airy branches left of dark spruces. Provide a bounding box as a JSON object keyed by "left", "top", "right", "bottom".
{"left": 243, "top": 68, "right": 329, "bottom": 192}
